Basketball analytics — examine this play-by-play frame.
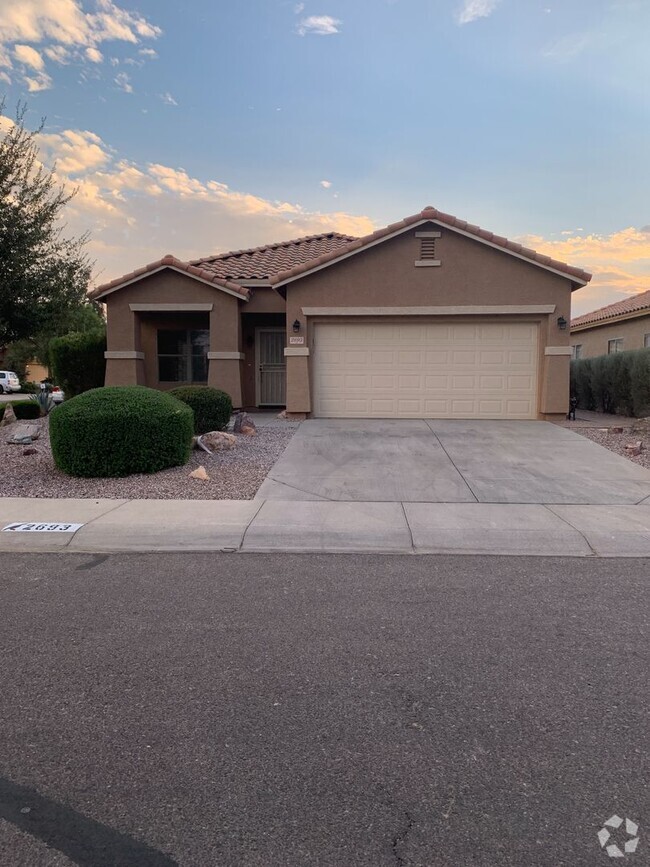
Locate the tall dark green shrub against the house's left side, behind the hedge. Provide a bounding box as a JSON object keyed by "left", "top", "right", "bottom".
{"left": 48, "top": 329, "right": 106, "bottom": 398}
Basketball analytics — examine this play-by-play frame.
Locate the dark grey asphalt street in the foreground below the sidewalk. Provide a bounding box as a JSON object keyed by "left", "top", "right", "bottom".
{"left": 0, "top": 554, "right": 650, "bottom": 867}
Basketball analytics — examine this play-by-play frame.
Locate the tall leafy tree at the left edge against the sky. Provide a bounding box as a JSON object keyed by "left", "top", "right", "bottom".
{"left": 0, "top": 103, "right": 92, "bottom": 346}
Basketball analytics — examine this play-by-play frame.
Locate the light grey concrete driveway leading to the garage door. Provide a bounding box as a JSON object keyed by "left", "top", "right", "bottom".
{"left": 257, "top": 419, "right": 650, "bottom": 505}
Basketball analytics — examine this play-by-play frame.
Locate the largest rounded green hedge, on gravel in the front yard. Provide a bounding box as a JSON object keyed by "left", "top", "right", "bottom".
{"left": 50, "top": 385, "right": 194, "bottom": 478}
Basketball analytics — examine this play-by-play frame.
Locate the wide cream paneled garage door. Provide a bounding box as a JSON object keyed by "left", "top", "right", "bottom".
{"left": 312, "top": 321, "right": 538, "bottom": 419}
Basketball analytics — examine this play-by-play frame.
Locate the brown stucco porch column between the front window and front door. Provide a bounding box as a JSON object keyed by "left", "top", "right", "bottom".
{"left": 208, "top": 299, "right": 244, "bottom": 407}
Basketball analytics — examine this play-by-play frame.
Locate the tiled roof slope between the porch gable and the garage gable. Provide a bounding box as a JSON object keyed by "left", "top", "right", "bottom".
{"left": 191, "top": 232, "right": 355, "bottom": 280}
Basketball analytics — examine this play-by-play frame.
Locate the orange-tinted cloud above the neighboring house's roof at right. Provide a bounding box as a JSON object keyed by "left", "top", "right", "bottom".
{"left": 517, "top": 226, "right": 650, "bottom": 316}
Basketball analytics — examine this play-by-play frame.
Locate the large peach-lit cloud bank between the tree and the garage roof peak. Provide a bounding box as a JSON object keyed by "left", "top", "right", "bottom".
{"left": 0, "top": 116, "right": 376, "bottom": 282}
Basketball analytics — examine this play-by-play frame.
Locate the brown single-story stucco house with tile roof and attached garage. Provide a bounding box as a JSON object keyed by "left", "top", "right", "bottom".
{"left": 92, "top": 207, "right": 591, "bottom": 419}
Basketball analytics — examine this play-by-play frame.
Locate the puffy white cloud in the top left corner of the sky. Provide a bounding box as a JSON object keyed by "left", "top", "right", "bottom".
{"left": 0, "top": 0, "right": 162, "bottom": 90}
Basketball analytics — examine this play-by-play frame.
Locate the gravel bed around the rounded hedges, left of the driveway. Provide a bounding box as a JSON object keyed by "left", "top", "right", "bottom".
{"left": 0, "top": 418, "right": 297, "bottom": 500}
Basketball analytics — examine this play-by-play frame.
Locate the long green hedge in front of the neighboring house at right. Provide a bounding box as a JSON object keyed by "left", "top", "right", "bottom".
{"left": 571, "top": 349, "right": 650, "bottom": 418}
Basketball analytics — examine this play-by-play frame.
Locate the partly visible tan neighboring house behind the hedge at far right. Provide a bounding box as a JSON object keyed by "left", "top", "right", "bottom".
{"left": 571, "top": 291, "right": 650, "bottom": 358}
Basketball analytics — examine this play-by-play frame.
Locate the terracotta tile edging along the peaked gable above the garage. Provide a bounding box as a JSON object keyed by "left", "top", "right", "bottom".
{"left": 271, "top": 205, "right": 591, "bottom": 284}
